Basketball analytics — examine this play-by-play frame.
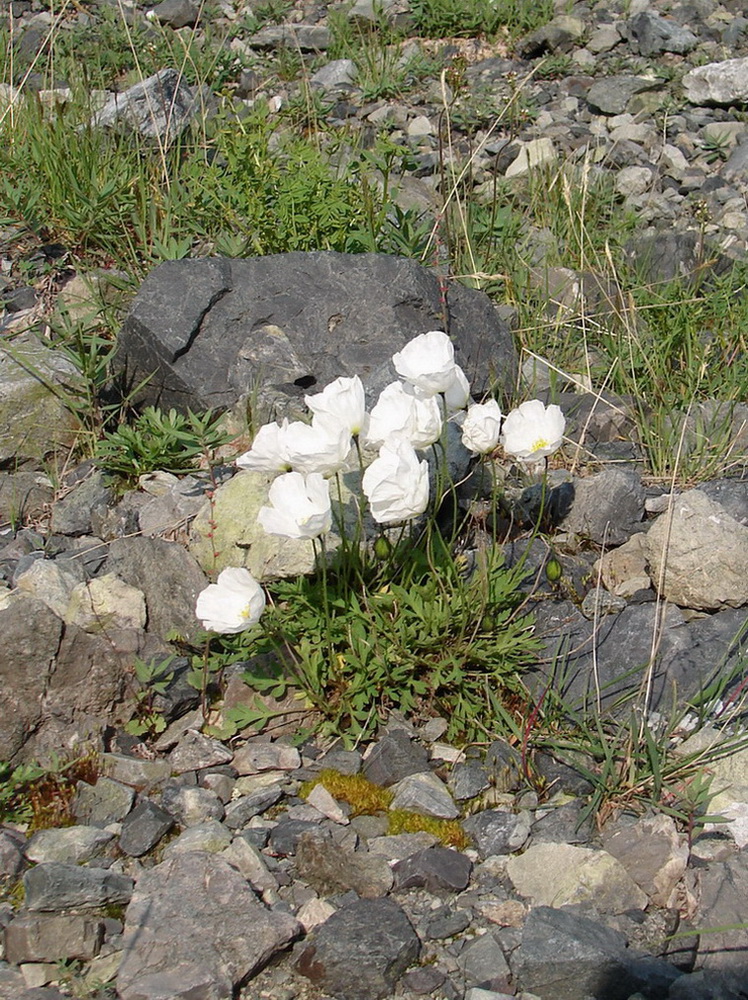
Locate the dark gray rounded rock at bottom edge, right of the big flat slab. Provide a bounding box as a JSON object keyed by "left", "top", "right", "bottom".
{"left": 296, "top": 899, "right": 420, "bottom": 1000}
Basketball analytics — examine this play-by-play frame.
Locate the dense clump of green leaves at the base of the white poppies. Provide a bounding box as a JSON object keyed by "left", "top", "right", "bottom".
{"left": 243, "top": 538, "right": 538, "bottom": 740}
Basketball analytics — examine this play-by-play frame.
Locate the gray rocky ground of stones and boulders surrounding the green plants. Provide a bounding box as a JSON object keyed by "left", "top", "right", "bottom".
{"left": 0, "top": 0, "right": 748, "bottom": 1000}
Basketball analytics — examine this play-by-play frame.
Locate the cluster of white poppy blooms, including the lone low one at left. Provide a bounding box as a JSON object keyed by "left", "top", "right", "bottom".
{"left": 196, "top": 330, "right": 565, "bottom": 633}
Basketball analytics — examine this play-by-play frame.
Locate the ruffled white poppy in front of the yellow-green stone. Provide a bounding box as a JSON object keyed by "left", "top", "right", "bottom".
{"left": 257, "top": 472, "right": 332, "bottom": 538}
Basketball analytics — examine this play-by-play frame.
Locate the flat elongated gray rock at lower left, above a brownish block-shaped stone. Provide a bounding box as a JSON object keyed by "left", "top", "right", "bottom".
{"left": 23, "top": 862, "right": 133, "bottom": 911}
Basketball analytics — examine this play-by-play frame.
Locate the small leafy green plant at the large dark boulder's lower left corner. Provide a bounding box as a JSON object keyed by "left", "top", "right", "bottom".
{"left": 95, "top": 406, "right": 232, "bottom": 483}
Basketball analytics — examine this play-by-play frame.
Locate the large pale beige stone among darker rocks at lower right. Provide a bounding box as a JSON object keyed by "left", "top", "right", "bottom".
{"left": 507, "top": 844, "right": 648, "bottom": 913}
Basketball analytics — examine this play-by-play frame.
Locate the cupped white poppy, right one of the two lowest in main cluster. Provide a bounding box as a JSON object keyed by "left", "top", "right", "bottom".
{"left": 362, "top": 438, "right": 429, "bottom": 524}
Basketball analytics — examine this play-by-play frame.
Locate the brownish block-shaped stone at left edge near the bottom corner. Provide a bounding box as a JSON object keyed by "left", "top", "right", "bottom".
{"left": 5, "top": 913, "right": 104, "bottom": 965}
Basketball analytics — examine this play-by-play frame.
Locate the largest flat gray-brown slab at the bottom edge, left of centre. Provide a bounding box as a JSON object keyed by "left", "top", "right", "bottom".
{"left": 117, "top": 853, "right": 300, "bottom": 1000}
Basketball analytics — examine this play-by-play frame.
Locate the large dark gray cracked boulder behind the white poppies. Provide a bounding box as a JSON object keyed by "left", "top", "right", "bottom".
{"left": 118, "top": 251, "right": 517, "bottom": 420}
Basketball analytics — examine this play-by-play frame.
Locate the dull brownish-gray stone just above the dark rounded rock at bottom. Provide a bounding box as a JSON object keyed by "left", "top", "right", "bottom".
{"left": 296, "top": 829, "right": 393, "bottom": 899}
